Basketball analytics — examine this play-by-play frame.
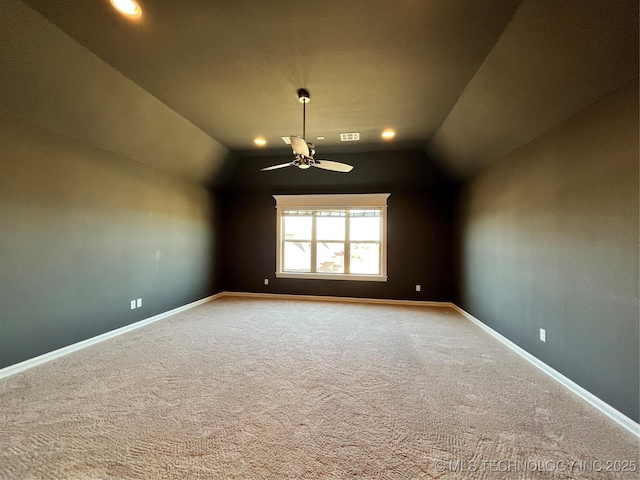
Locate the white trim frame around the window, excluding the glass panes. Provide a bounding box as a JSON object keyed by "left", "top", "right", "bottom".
{"left": 273, "top": 193, "right": 391, "bottom": 282}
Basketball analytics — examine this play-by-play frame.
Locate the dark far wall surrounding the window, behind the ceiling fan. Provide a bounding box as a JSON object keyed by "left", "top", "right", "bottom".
{"left": 223, "top": 151, "right": 454, "bottom": 301}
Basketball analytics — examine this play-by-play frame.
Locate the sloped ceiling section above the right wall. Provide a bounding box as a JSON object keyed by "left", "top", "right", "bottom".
{"left": 427, "top": 0, "right": 638, "bottom": 177}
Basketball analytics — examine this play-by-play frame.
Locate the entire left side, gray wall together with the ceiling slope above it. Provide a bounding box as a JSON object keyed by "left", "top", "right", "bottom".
{"left": 0, "top": 0, "right": 228, "bottom": 368}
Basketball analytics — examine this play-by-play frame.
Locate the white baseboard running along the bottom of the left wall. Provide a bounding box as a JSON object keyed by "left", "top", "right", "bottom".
{"left": 0, "top": 293, "right": 222, "bottom": 379}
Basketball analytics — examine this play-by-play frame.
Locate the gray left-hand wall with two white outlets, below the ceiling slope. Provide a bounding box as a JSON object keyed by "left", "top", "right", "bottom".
{"left": 0, "top": 110, "right": 220, "bottom": 368}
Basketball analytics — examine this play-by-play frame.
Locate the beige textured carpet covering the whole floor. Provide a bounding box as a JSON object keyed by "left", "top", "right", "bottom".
{"left": 0, "top": 298, "right": 640, "bottom": 479}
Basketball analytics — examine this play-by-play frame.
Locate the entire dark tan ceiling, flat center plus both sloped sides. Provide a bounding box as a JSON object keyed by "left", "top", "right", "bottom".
{"left": 5, "top": 0, "right": 638, "bottom": 183}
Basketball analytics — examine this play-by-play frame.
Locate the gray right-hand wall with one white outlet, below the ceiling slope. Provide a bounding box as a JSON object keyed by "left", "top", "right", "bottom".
{"left": 459, "top": 80, "right": 640, "bottom": 421}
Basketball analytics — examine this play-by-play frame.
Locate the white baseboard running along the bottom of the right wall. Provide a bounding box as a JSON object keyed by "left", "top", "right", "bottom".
{"left": 451, "top": 304, "right": 640, "bottom": 438}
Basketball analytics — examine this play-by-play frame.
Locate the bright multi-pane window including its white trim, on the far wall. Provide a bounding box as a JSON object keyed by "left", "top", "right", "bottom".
{"left": 273, "top": 193, "right": 390, "bottom": 282}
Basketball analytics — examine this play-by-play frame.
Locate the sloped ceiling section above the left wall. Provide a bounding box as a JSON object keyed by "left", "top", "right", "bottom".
{"left": 0, "top": 0, "right": 229, "bottom": 183}
